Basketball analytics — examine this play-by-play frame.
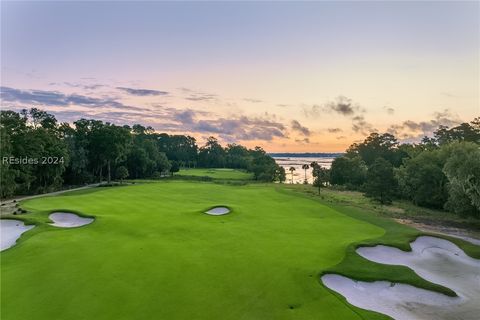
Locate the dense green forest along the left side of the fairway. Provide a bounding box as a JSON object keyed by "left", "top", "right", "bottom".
{"left": 0, "top": 108, "right": 285, "bottom": 198}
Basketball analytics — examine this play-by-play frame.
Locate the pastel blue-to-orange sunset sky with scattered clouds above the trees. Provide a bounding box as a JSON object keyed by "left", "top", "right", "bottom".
{"left": 0, "top": 1, "right": 480, "bottom": 152}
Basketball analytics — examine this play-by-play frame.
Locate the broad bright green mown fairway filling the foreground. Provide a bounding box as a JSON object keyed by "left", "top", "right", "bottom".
{"left": 1, "top": 181, "right": 386, "bottom": 320}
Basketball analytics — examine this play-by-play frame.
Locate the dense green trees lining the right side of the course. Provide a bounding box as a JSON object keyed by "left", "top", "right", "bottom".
{"left": 330, "top": 118, "right": 480, "bottom": 217}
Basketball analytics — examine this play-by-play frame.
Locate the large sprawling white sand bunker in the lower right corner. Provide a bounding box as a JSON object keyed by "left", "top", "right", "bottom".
{"left": 322, "top": 237, "right": 480, "bottom": 320}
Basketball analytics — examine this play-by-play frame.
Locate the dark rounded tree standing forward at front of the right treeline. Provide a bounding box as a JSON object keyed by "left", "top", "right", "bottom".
{"left": 365, "top": 158, "right": 396, "bottom": 204}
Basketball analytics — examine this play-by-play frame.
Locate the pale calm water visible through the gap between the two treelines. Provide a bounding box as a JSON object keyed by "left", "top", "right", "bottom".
{"left": 273, "top": 156, "right": 335, "bottom": 183}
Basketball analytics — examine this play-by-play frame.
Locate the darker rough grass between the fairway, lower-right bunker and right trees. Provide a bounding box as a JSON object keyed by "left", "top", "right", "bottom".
{"left": 282, "top": 185, "right": 480, "bottom": 296}
